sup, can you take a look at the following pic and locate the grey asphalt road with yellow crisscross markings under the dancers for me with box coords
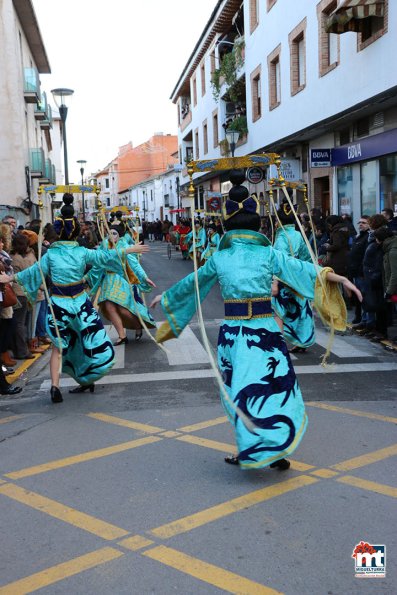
[0,243,397,595]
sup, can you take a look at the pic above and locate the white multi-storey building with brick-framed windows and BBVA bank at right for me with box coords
[171,0,397,218]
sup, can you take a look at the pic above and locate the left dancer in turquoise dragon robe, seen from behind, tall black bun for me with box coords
[0,194,148,403]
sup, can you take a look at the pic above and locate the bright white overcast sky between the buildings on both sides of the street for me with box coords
[33,0,217,183]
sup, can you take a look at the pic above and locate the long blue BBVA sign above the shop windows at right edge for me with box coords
[331,129,397,166]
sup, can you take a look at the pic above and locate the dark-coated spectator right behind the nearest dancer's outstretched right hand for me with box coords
[347,215,369,328]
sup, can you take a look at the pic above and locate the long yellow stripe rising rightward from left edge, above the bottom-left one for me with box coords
[4,436,162,479]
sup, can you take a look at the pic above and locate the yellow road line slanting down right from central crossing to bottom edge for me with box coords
[142,545,280,595]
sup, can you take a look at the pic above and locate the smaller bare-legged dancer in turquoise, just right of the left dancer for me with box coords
[85,225,156,346]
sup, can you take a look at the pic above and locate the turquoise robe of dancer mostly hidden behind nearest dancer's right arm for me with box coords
[272,225,316,348]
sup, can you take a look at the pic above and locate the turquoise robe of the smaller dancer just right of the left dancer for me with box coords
[85,234,156,328]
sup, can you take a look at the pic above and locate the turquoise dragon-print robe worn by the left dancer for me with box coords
[15,242,124,385]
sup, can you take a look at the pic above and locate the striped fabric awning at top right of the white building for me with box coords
[325,0,385,34]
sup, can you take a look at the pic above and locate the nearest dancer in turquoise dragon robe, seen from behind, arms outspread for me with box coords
[152,170,361,469]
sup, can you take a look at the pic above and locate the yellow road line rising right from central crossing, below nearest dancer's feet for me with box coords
[150,475,319,539]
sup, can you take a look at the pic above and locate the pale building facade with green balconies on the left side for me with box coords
[0,0,61,223]
